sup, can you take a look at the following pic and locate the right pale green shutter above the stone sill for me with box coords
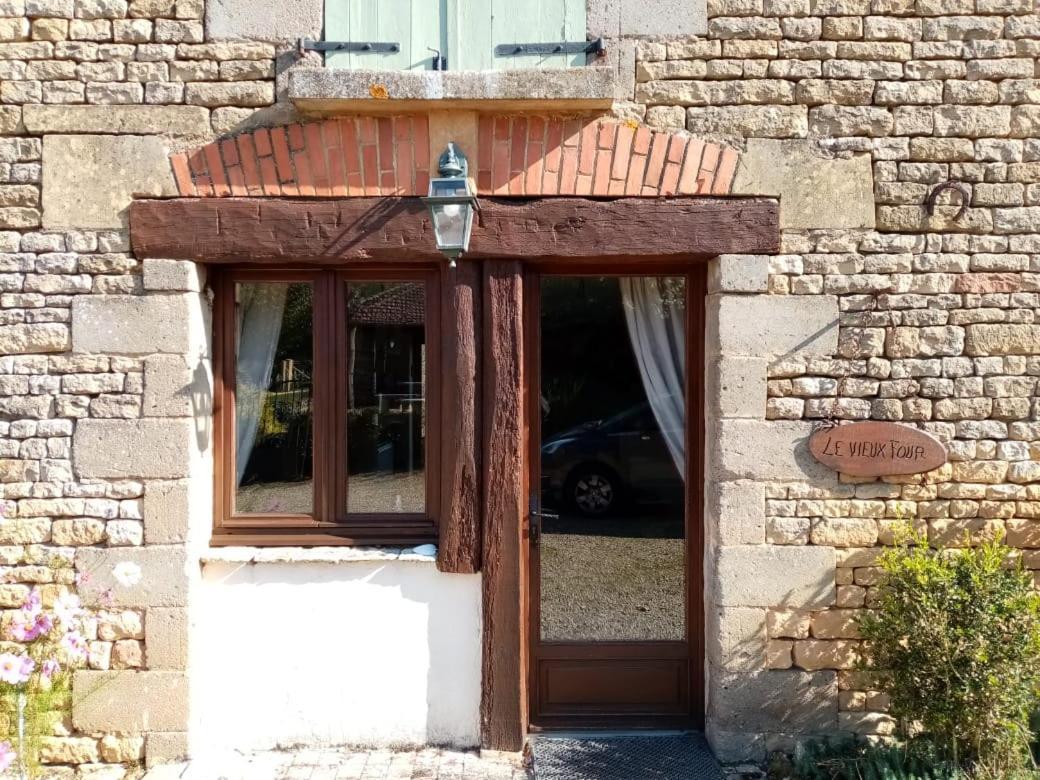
[448,0,588,71]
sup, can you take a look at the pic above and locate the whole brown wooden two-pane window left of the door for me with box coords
[214,269,439,545]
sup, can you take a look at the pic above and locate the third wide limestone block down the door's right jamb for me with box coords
[714,545,836,609]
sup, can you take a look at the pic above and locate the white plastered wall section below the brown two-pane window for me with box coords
[190,560,480,756]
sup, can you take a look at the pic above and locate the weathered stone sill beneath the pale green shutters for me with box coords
[289,66,617,113]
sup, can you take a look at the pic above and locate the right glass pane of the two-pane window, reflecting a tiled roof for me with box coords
[346,282,426,514]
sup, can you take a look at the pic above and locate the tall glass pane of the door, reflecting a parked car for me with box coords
[538,277,686,642]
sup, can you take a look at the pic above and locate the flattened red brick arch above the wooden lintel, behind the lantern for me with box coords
[171,114,738,198]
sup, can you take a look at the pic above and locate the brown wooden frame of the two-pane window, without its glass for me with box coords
[210,263,441,546]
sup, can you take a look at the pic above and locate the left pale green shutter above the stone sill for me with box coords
[326,0,451,71]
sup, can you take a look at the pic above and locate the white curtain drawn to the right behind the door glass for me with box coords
[620,277,686,479]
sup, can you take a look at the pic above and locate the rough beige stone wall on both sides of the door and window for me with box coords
[0,0,1040,778]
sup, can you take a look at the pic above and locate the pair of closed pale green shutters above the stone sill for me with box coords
[326,0,587,71]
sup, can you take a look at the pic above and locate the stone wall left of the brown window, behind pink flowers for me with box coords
[0,0,282,780]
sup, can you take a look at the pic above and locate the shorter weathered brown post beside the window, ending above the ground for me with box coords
[437,260,483,574]
